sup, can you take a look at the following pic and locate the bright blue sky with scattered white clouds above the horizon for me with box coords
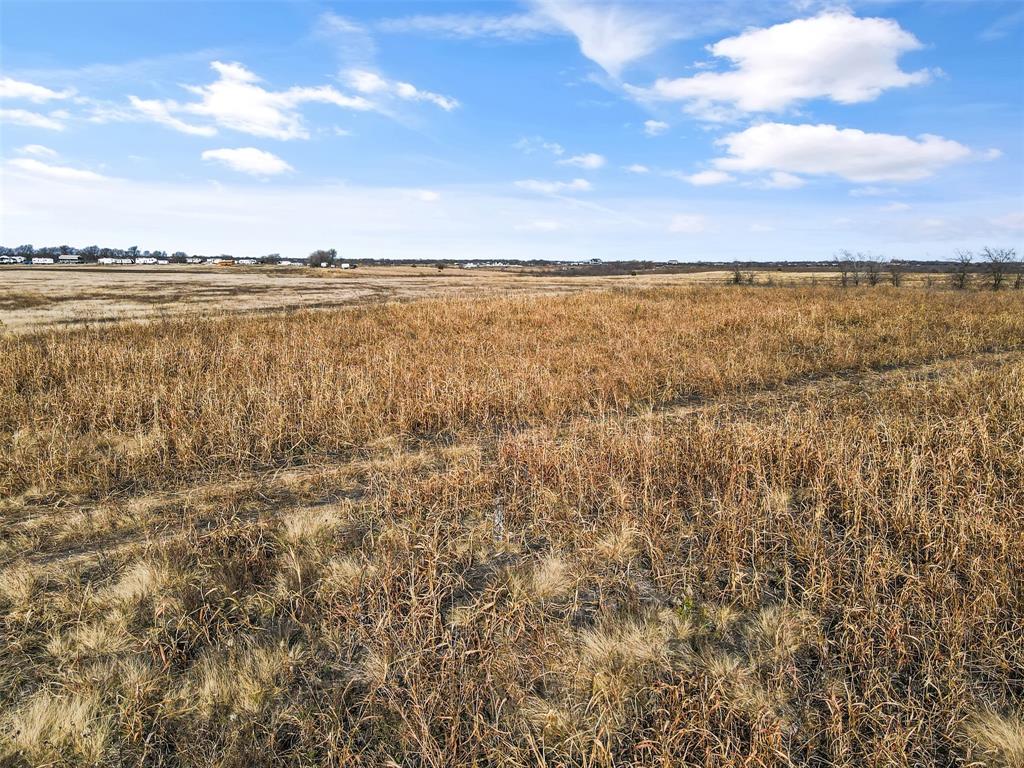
[0,0,1024,261]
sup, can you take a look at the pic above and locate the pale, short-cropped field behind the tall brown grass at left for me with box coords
[0,265,737,333]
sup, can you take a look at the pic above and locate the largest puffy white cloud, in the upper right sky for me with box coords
[631,11,931,121]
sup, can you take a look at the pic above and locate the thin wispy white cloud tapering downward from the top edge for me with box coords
[535,0,678,77]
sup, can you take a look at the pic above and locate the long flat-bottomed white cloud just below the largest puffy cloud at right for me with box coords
[714,123,971,185]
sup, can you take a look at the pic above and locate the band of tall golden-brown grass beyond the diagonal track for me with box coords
[6,289,1024,497]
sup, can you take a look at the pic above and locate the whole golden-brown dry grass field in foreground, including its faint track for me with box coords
[0,284,1024,768]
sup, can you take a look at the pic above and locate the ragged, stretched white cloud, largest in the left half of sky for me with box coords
[129,61,374,140]
